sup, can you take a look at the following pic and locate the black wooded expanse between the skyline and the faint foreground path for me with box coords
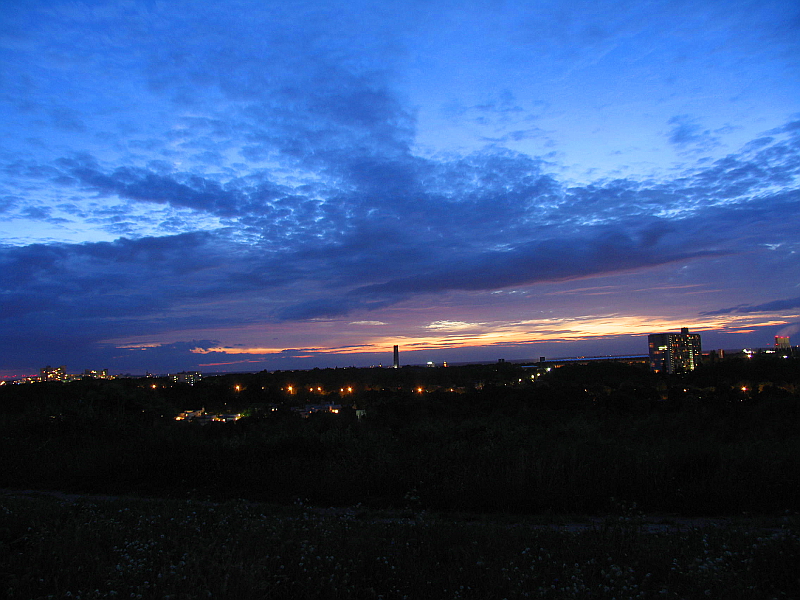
[0,358,800,514]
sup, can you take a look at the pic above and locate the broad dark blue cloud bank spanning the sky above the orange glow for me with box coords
[0,118,800,338]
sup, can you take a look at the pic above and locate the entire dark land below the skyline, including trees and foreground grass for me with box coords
[0,359,800,600]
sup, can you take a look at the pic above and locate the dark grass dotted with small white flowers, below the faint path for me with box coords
[0,495,800,600]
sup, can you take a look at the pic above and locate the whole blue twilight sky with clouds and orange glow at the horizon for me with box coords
[0,0,800,378]
